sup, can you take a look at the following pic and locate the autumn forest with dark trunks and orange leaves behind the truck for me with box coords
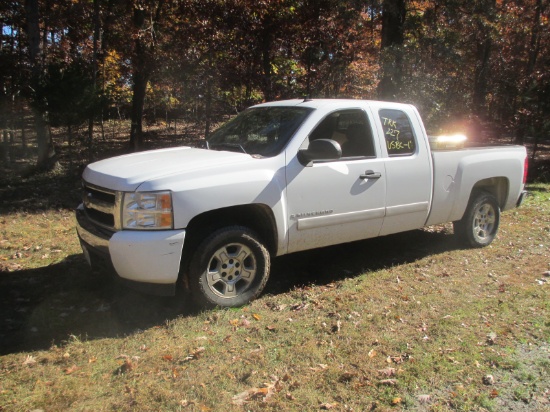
[0,0,550,172]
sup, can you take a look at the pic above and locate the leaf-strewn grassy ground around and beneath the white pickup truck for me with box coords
[0,127,550,412]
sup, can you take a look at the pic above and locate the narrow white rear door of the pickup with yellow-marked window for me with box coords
[375,108,433,235]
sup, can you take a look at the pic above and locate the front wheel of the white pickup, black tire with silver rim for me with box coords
[188,226,270,308]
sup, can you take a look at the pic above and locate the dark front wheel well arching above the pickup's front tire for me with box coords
[184,204,278,256]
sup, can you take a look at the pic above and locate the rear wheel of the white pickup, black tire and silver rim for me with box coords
[453,192,500,247]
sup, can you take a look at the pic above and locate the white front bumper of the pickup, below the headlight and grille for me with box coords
[76,205,185,295]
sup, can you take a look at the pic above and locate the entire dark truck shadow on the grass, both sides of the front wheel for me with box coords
[0,230,457,355]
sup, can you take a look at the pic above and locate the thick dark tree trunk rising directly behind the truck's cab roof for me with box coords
[377,0,407,101]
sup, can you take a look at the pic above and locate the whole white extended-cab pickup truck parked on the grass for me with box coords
[76,99,527,307]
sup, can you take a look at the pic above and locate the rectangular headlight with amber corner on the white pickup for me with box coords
[122,192,174,230]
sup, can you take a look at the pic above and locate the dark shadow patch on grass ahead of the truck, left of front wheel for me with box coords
[0,255,196,355]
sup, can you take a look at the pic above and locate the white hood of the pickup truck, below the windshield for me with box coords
[82,147,253,191]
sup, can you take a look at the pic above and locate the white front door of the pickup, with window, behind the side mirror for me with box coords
[286,109,386,252]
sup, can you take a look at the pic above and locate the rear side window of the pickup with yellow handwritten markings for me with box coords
[379,109,416,156]
